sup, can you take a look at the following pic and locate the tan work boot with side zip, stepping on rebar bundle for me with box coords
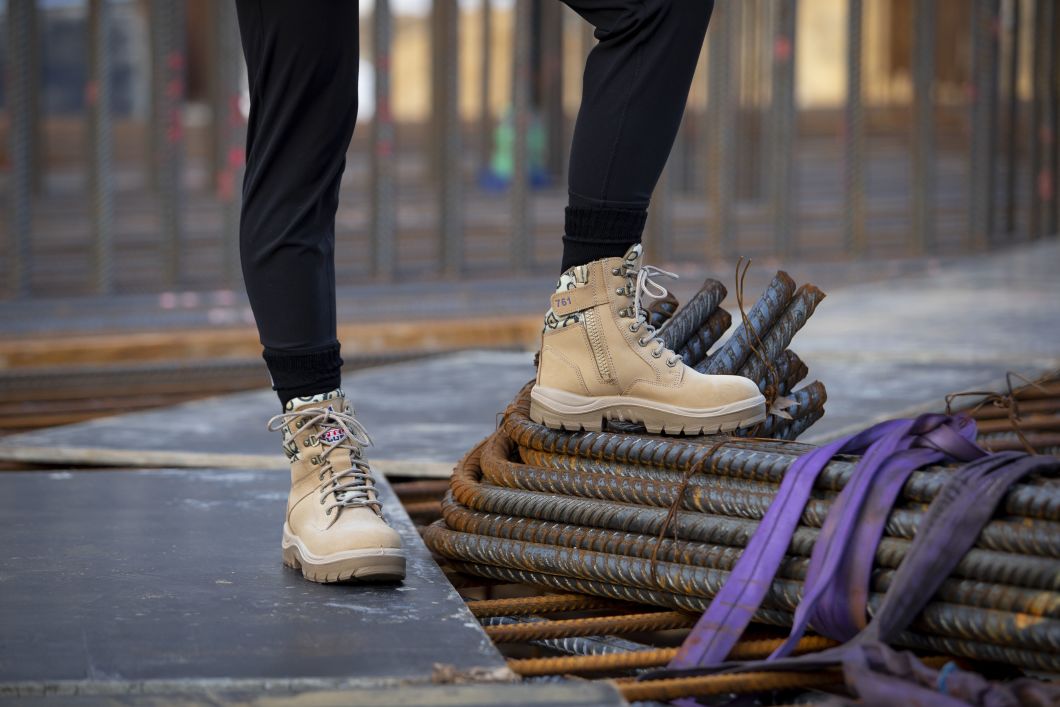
[530,244,765,435]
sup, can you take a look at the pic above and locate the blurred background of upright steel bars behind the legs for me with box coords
[0,0,1060,299]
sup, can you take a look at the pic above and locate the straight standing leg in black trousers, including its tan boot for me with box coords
[236,0,405,582]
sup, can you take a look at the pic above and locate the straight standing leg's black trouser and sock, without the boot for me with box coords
[236,0,359,403]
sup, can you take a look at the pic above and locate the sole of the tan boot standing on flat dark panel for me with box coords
[282,524,405,584]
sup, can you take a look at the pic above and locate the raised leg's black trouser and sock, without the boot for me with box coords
[561,0,713,271]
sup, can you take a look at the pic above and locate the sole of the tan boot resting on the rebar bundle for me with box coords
[530,386,765,435]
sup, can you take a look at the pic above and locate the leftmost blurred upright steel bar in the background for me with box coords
[4,0,35,297]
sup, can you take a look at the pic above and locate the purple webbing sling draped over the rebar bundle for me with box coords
[657,414,1060,705]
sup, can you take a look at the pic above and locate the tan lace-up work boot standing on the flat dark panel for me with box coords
[268,390,405,582]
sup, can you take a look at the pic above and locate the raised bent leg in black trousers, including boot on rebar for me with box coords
[530,0,765,434]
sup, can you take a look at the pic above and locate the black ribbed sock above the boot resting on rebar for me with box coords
[560,201,648,272]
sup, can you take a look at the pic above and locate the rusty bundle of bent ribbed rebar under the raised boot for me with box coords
[424,273,1060,672]
